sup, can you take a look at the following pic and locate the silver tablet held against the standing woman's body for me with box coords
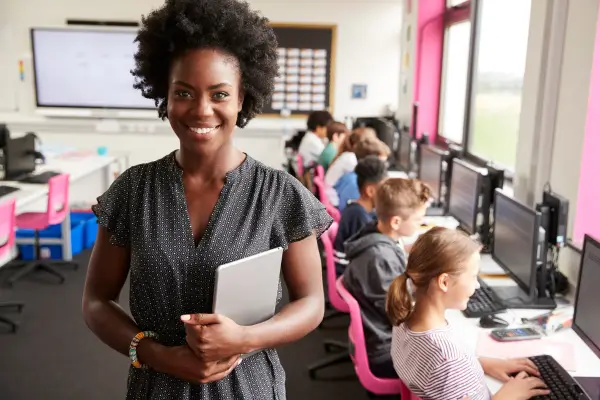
[213,247,283,326]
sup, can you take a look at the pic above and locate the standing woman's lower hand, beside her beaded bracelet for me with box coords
[140,341,242,384]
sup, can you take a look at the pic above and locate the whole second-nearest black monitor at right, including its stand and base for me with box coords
[492,189,556,309]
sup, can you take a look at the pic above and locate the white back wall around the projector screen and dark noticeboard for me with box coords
[0,0,402,123]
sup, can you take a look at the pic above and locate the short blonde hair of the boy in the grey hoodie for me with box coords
[375,178,431,221]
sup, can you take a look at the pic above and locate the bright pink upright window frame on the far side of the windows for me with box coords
[412,0,471,142]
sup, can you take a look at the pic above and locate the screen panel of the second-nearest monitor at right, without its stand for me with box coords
[492,190,541,293]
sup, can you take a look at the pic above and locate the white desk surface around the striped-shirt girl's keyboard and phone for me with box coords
[446,278,600,393]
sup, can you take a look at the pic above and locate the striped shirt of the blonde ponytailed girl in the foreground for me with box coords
[392,324,491,400]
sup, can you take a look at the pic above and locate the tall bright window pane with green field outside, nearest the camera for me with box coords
[468,0,531,170]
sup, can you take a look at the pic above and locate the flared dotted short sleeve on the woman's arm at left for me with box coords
[92,170,131,247]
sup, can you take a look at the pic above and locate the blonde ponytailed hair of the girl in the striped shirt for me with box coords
[386,227,481,326]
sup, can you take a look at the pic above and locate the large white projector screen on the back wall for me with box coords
[31,28,155,109]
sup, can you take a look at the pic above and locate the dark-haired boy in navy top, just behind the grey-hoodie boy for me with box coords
[333,156,387,276]
